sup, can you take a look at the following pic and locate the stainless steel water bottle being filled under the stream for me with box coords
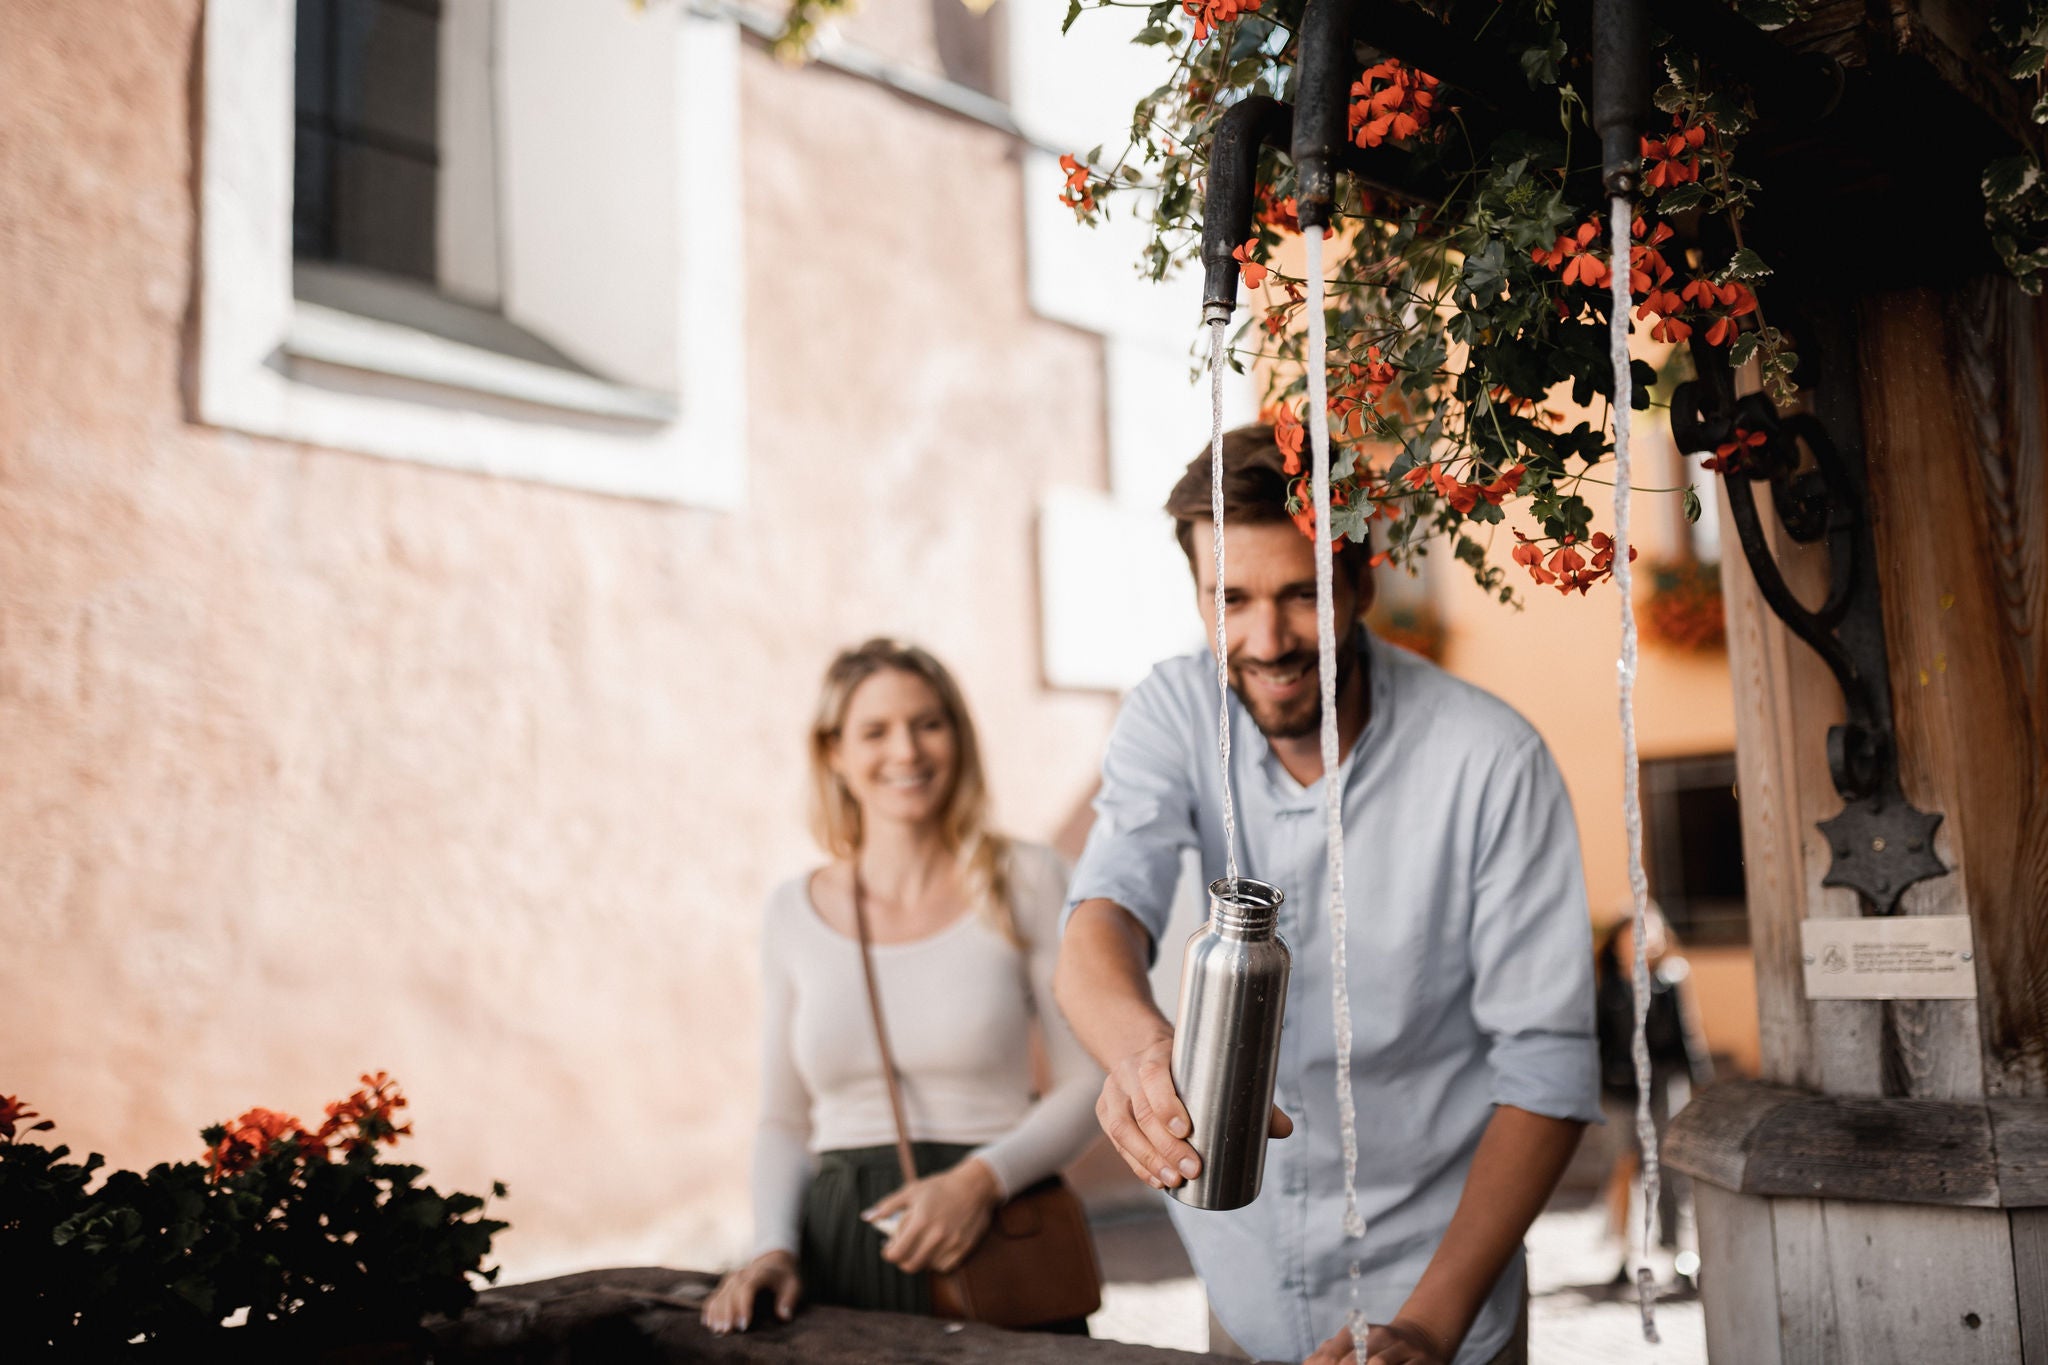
[1171,876,1294,1209]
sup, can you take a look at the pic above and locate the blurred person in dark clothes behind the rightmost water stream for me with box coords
[1593,902,1714,1283]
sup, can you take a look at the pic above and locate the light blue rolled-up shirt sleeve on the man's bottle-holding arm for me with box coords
[1061,671,1214,954]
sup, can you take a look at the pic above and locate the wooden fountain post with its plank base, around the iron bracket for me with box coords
[1667,278,2048,1365]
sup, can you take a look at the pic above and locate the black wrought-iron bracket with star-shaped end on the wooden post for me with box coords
[1671,306,1948,915]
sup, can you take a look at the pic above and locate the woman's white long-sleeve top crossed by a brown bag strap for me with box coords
[754,843,1102,1254]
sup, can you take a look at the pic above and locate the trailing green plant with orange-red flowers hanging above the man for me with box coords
[1040,0,2048,602]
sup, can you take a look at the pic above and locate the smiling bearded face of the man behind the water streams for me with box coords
[1192,518,1372,739]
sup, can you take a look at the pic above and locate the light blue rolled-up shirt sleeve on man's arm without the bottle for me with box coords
[1470,737,1599,1121]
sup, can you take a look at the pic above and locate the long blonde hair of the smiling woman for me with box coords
[811,636,1022,948]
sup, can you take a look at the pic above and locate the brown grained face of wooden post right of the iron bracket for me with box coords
[1860,280,2048,1095]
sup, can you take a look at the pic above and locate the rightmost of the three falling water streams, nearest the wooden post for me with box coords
[1608,194,1661,1342]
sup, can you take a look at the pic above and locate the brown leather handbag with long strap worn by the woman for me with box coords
[854,872,1102,1328]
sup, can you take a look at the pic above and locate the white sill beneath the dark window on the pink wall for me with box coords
[283,299,678,422]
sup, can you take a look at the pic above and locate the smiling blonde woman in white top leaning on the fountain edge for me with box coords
[702,639,1102,1332]
